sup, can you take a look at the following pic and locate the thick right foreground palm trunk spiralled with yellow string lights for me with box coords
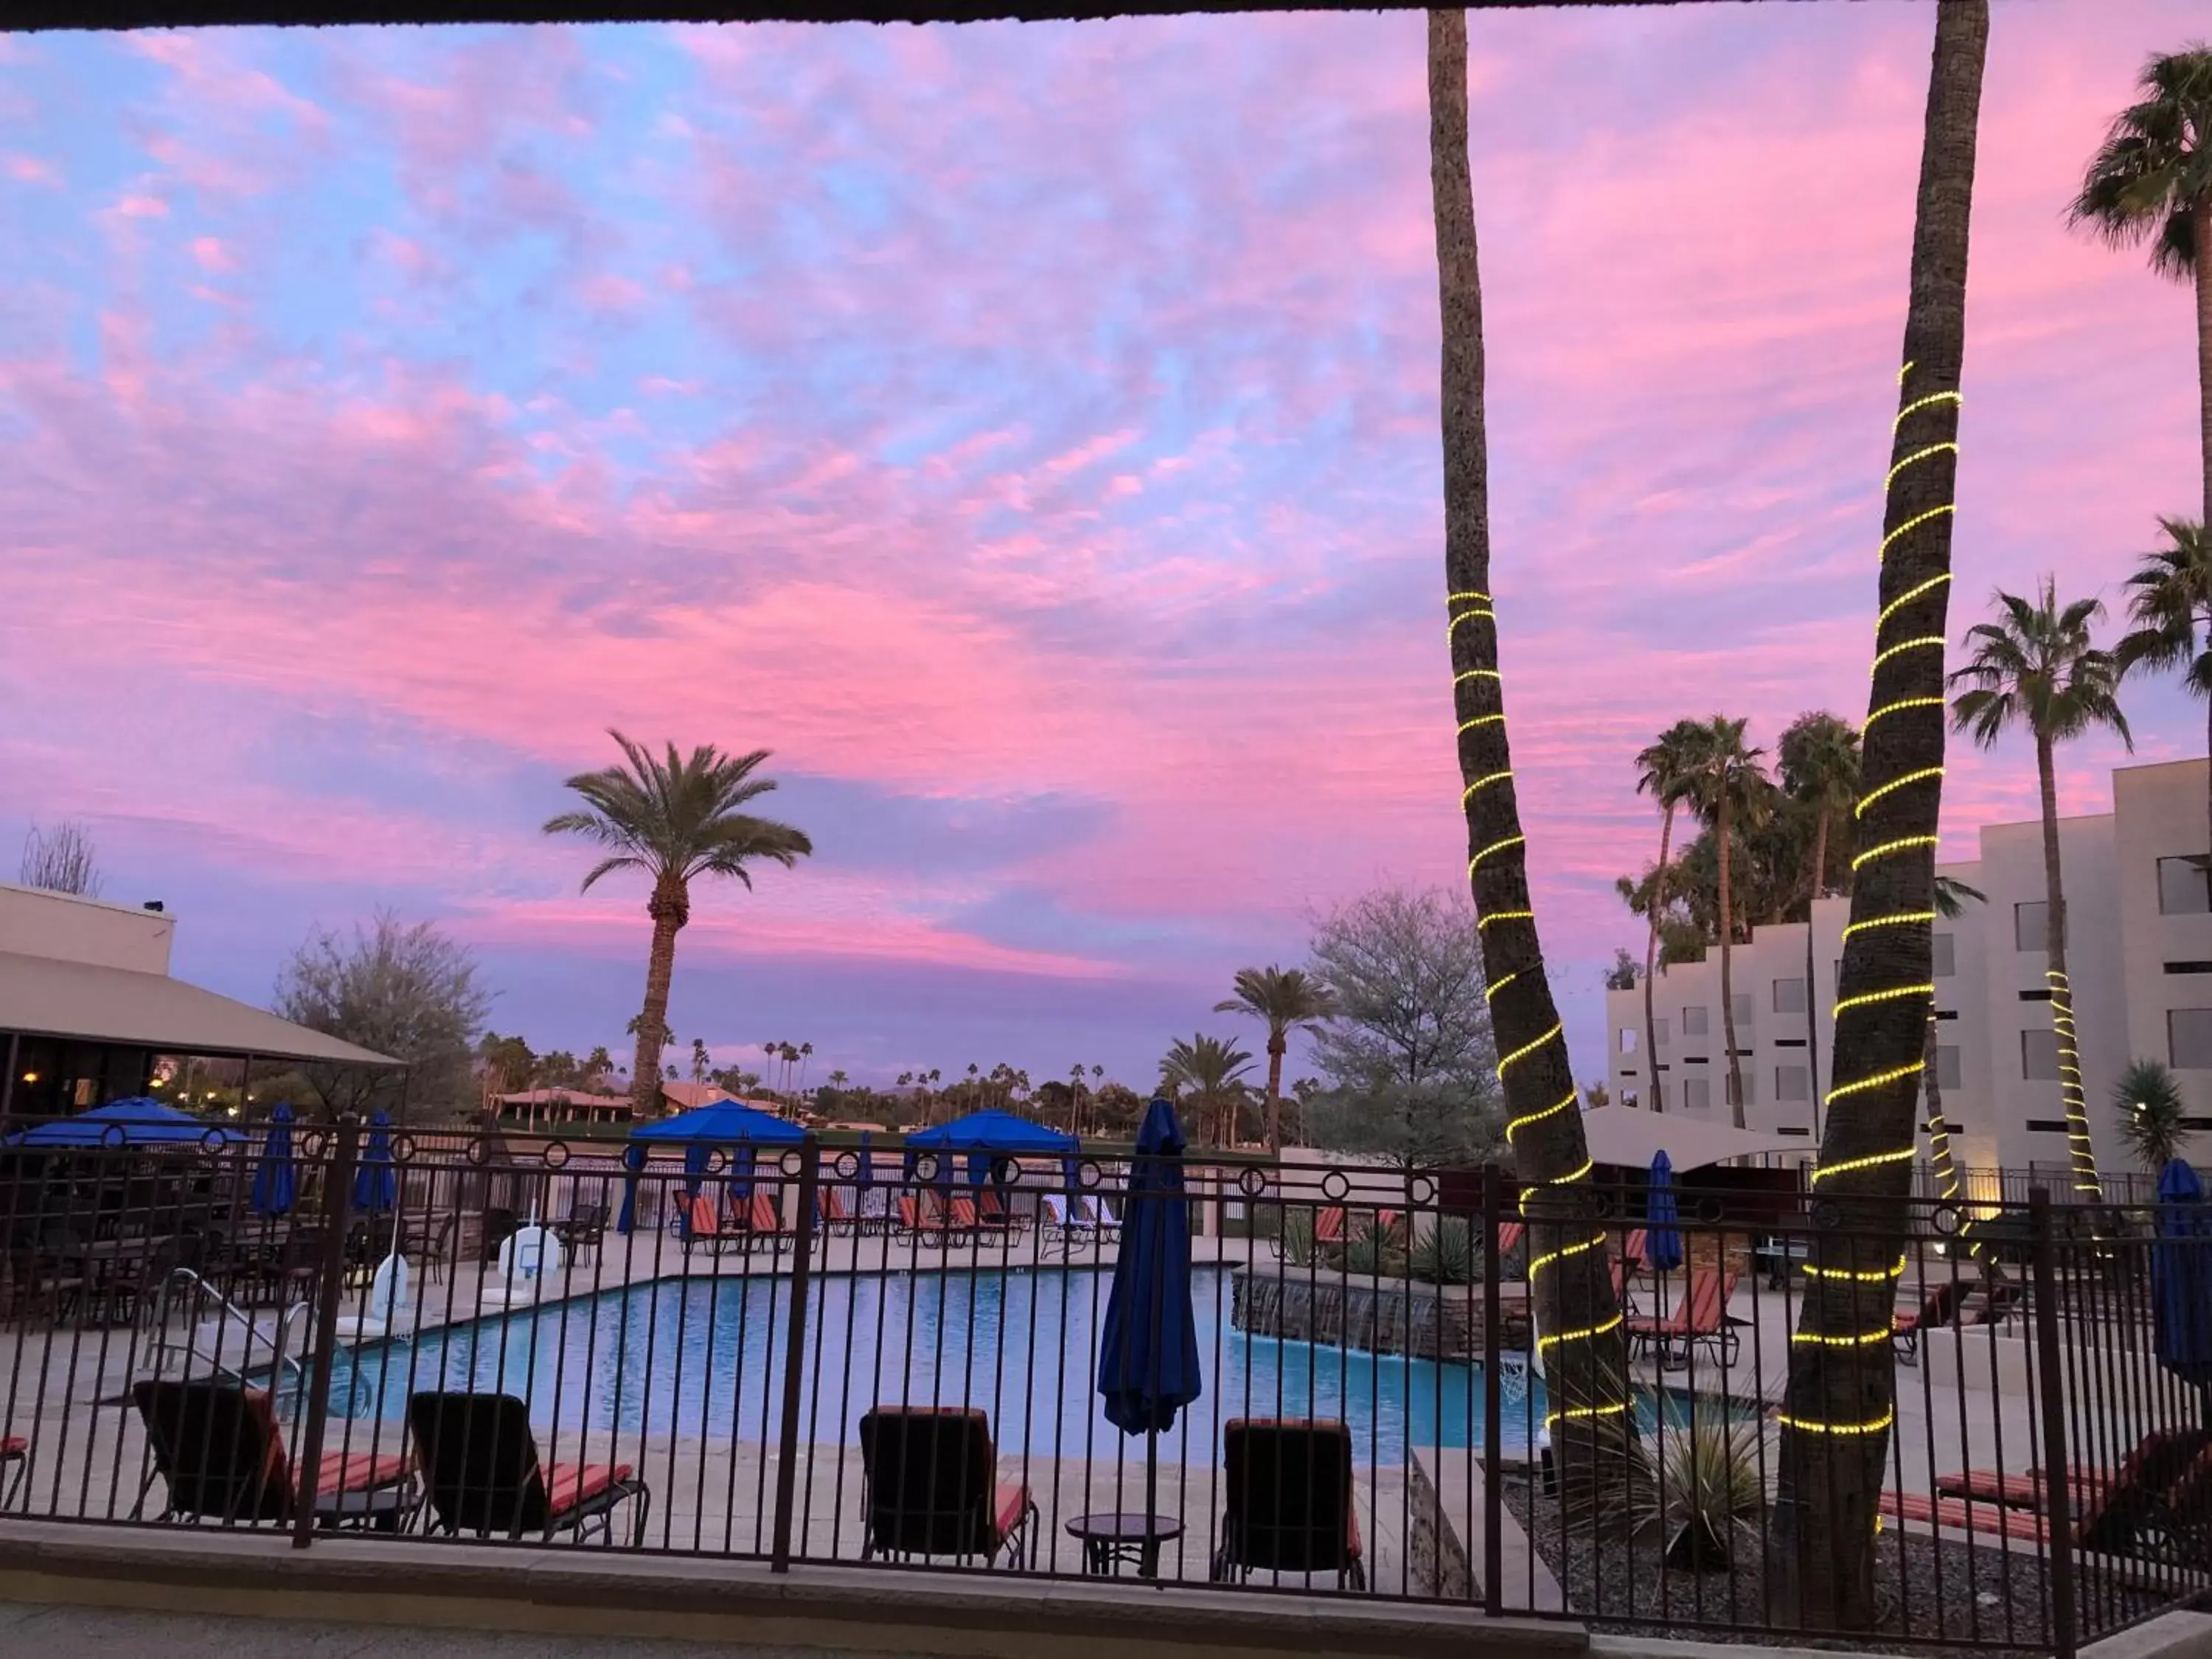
[1767,0,1989,1630]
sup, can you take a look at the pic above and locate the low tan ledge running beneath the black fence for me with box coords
[0,1520,1590,1659]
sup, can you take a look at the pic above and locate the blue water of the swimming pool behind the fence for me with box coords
[332,1267,1708,1464]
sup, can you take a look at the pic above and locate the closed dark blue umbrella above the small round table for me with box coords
[1099,1099,1203,1513]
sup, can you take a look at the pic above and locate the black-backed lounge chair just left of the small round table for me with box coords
[860,1405,1037,1566]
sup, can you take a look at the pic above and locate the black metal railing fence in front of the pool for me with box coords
[0,1124,2212,1652]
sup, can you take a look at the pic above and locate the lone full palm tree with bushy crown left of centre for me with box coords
[544,730,814,1117]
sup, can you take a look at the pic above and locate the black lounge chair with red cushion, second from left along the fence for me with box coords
[407,1394,653,1548]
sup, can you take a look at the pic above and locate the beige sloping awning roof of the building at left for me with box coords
[0,951,407,1066]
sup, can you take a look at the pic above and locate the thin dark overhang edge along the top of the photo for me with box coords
[0,0,1809,29]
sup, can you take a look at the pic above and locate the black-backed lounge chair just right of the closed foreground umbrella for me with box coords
[1212,1418,1367,1590]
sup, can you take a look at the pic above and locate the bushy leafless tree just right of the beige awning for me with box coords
[272,909,491,1113]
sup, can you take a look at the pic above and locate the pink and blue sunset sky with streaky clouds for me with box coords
[0,0,2205,1106]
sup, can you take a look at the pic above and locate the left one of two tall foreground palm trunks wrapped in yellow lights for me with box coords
[1429,11,1635,1509]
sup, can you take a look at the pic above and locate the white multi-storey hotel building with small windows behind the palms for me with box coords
[1606,761,2212,1175]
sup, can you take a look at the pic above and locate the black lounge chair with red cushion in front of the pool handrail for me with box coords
[131,1380,416,1528]
